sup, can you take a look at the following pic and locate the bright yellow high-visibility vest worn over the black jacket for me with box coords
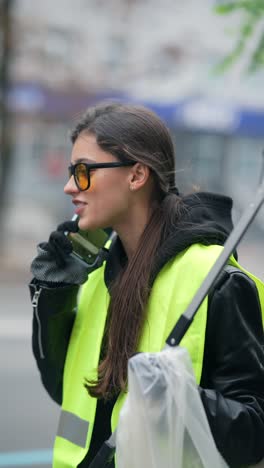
[53,244,264,468]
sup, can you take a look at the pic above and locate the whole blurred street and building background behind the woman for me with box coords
[0,0,264,467]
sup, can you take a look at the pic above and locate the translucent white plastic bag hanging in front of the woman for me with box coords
[116,347,227,468]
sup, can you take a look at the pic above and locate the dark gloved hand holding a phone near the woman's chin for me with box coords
[31,221,89,285]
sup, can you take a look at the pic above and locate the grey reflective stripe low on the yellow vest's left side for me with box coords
[57,410,89,448]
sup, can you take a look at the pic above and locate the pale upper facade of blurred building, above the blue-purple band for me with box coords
[9,0,264,101]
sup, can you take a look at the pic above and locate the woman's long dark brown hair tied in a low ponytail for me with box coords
[71,103,184,399]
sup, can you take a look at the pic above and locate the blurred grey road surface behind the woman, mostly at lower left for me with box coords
[0,239,264,467]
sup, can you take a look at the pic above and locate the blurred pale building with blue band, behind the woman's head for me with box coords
[3,0,264,266]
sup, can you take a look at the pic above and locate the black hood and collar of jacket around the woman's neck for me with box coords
[104,192,236,289]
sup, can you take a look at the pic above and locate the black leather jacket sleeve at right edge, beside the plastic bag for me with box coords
[199,269,264,467]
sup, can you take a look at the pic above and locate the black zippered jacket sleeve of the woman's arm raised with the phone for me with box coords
[29,280,79,404]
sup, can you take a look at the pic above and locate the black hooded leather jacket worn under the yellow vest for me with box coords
[30,194,264,467]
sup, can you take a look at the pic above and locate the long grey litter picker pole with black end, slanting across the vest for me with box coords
[89,158,264,468]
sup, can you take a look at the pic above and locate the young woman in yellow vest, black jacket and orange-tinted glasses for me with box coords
[30,100,264,467]
